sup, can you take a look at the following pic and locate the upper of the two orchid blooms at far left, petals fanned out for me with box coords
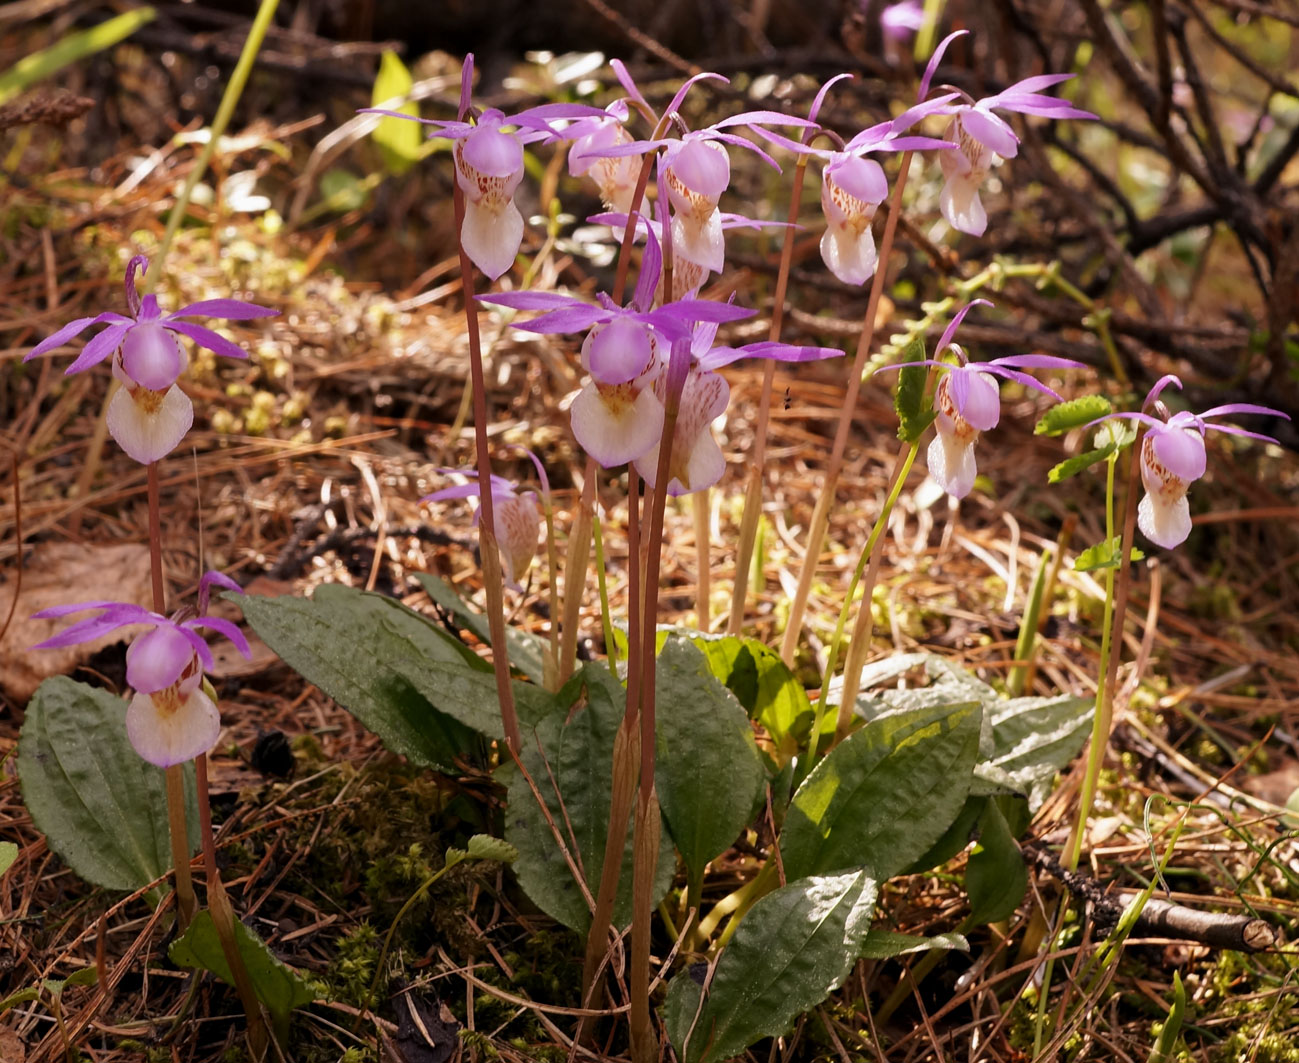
[23,255,279,465]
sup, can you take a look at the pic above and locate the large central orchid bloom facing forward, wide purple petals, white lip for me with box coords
[479,231,753,469]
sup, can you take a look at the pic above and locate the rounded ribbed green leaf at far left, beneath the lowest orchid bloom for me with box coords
[18,676,199,890]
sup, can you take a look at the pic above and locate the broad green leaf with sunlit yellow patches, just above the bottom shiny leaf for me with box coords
[781,700,983,881]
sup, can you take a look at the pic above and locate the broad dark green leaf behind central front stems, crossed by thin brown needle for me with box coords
[505,661,677,933]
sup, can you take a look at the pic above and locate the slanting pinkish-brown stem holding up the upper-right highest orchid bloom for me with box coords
[781,151,914,665]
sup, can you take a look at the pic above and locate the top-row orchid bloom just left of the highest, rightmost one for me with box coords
[757,74,955,285]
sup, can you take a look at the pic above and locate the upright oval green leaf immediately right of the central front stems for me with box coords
[655,638,766,877]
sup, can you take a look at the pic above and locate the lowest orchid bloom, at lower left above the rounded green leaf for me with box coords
[32,572,251,768]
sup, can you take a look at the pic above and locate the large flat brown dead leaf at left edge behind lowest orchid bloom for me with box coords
[0,542,153,701]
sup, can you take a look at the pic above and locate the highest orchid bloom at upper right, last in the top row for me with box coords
[920,30,1096,237]
